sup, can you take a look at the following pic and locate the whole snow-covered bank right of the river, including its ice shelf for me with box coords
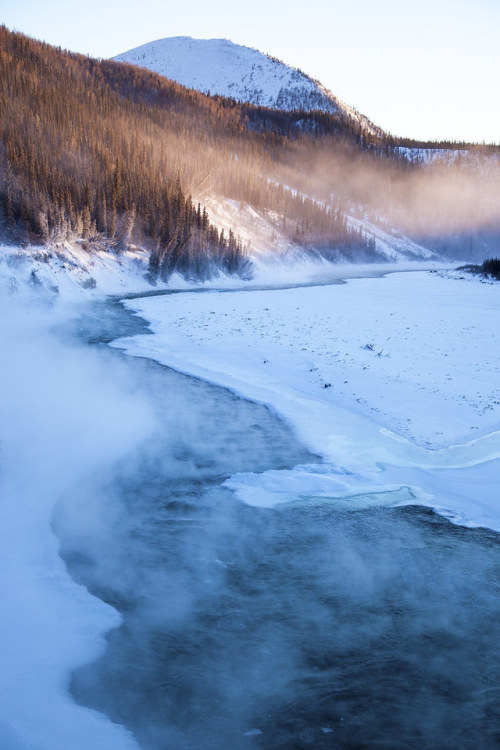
[117,272,500,529]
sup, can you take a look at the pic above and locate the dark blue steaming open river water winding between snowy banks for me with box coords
[54,301,500,750]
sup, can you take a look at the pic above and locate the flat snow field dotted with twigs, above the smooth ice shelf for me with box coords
[121,272,500,449]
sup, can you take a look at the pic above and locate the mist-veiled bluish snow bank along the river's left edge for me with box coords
[0,292,152,750]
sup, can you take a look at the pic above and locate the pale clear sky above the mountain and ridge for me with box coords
[0,0,500,143]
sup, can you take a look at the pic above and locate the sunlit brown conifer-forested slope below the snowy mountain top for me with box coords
[0,27,498,279]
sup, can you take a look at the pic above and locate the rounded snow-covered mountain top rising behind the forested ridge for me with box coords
[113,36,381,134]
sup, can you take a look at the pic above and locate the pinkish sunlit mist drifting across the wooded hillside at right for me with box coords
[194,136,500,261]
